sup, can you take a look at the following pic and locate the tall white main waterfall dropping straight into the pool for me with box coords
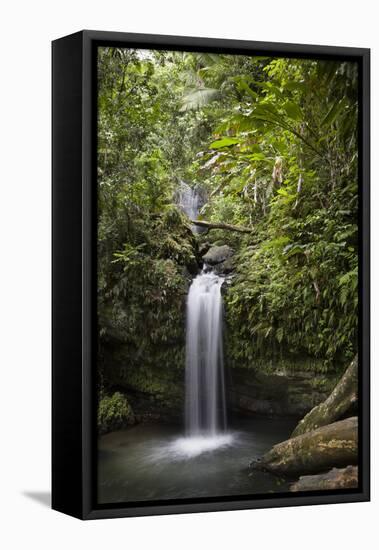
[185,271,226,436]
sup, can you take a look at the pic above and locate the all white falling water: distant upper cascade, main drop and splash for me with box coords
[172,181,233,456]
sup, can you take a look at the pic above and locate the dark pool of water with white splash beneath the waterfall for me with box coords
[98,417,295,504]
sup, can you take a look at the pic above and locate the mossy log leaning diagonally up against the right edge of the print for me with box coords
[291,357,358,437]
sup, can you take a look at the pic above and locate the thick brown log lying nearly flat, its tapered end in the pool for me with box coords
[251,416,358,477]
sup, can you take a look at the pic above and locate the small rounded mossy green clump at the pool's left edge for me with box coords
[97,392,135,434]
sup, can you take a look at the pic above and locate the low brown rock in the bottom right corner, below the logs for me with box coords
[290,466,358,492]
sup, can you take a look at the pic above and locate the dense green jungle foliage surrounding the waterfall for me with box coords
[98,48,358,432]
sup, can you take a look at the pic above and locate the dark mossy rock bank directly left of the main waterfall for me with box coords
[98,207,198,415]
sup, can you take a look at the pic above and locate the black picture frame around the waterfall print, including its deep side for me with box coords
[52,30,370,519]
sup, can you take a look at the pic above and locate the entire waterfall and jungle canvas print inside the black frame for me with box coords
[96,46,360,504]
